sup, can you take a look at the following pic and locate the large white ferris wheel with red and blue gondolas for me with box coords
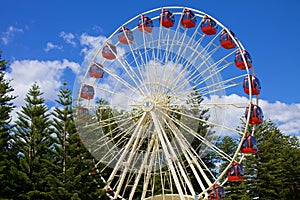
[73,6,263,200]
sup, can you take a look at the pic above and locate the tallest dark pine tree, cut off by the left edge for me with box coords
[0,52,16,199]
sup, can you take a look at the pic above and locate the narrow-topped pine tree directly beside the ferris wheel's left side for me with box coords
[50,82,106,199]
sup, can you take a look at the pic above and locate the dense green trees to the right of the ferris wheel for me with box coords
[226,120,300,200]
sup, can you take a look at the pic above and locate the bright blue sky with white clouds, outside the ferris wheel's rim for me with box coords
[0,0,300,136]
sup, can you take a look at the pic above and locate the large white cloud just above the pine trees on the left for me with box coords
[7,59,79,106]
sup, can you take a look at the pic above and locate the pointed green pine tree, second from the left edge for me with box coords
[14,83,52,199]
